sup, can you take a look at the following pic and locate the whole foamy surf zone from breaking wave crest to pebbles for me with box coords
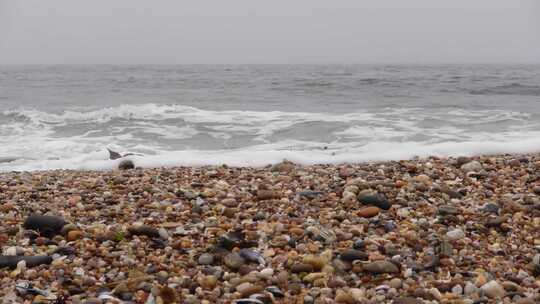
[0,104,540,171]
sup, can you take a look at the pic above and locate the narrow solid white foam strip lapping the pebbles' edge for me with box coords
[0,138,540,171]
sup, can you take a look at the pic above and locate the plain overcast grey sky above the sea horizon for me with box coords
[0,0,540,64]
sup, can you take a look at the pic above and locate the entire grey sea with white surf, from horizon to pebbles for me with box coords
[0,64,540,172]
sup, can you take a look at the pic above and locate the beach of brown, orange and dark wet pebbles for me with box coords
[0,154,540,304]
